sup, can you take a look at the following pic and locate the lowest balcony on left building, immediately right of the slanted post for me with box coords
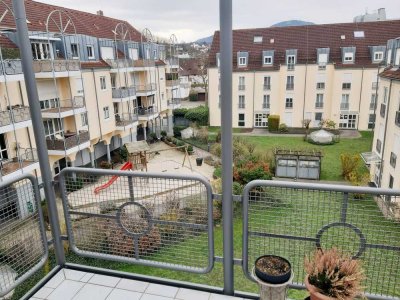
[46,130,90,155]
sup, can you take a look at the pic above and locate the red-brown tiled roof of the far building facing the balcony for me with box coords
[209,20,400,70]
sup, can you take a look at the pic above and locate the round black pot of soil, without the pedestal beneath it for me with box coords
[255,255,292,284]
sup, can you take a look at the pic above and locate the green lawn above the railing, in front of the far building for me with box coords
[244,131,373,181]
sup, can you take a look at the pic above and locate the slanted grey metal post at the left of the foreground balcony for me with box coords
[12,0,65,265]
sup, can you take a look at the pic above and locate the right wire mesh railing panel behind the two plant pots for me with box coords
[243,181,400,299]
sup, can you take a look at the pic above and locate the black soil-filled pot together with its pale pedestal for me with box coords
[253,255,293,300]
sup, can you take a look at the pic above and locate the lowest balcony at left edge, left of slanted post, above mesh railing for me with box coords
[0,148,39,180]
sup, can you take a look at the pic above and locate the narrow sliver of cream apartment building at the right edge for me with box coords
[363,38,400,189]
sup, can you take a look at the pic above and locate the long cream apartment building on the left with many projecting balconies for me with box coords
[0,0,180,180]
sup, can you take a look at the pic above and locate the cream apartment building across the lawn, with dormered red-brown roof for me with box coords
[208,20,400,130]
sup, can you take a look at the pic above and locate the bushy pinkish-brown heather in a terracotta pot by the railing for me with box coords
[304,248,365,300]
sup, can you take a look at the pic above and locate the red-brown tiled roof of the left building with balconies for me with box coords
[1,0,141,42]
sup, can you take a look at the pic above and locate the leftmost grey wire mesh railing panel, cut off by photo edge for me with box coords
[0,176,48,297]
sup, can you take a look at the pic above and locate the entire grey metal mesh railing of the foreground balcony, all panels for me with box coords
[0,168,400,300]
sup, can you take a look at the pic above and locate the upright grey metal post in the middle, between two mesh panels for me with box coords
[219,0,234,295]
